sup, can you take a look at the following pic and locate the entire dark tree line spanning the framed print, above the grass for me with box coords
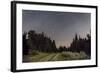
[23,30,91,55]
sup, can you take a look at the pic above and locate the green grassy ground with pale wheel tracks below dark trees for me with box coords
[23,52,88,62]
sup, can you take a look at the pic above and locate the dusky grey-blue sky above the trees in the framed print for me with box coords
[22,10,91,47]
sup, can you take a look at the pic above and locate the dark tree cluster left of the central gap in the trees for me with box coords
[23,30,57,54]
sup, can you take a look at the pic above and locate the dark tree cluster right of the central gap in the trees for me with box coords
[70,34,91,56]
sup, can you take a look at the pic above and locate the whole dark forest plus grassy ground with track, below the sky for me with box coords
[22,30,91,62]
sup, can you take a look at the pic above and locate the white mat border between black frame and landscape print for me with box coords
[16,4,96,70]
